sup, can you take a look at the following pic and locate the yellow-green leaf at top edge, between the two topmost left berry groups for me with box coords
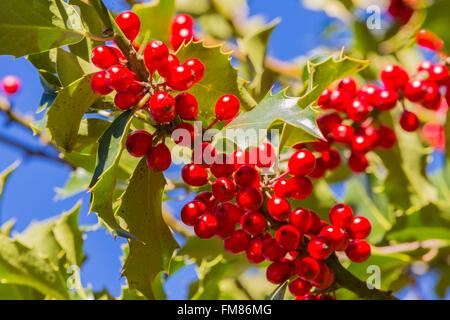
[133,0,176,42]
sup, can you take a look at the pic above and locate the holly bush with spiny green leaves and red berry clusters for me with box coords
[0,0,450,300]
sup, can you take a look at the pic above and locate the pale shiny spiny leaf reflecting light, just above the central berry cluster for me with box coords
[217,91,322,149]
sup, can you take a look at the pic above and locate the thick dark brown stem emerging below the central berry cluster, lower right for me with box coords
[326,255,398,300]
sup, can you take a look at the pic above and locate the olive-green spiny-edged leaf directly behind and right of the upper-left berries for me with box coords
[177,41,247,118]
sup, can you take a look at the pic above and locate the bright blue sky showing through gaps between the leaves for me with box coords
[0,0,442,298]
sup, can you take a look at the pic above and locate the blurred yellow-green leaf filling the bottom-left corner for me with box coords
[0,234,69,299]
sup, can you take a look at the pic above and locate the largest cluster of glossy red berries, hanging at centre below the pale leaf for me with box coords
[181,143,371,298]
